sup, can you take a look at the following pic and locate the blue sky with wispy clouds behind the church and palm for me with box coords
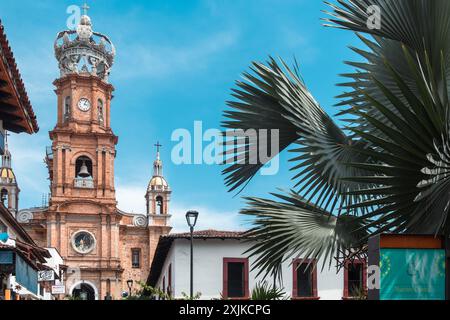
[0,0,358,230]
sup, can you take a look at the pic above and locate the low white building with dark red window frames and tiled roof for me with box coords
[148,230,367,300]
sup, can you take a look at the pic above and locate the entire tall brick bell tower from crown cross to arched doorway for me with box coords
[46,6,123,299]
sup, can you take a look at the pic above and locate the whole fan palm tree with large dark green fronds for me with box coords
[223,0,450,275]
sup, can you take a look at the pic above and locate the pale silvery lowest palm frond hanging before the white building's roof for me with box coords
[241,192,367,276]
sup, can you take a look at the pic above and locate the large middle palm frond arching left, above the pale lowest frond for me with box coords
[223,59,368,211]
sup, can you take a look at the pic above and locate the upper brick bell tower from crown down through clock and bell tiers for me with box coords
[50,10,118,205]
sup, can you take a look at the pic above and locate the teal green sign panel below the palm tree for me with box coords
[380,249,445,300]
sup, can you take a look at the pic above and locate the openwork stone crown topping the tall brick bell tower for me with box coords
[55,6,116,82]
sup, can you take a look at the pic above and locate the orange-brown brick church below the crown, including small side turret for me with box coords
[19,64,171,299]
